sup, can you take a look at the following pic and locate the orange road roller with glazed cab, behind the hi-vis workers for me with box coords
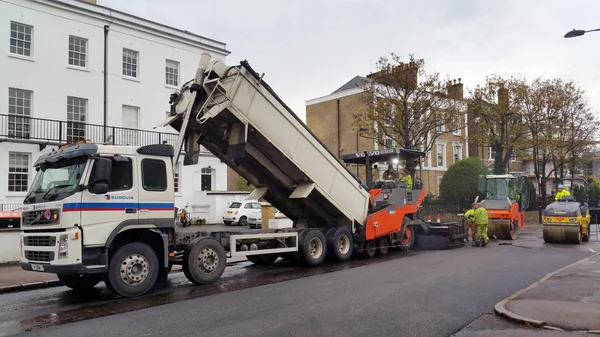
[479,174,530,240]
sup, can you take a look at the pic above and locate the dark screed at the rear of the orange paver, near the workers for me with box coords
[417,220,468,250]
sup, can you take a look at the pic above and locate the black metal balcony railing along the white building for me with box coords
[0,114,213,153]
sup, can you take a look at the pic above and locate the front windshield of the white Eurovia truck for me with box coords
[23,157,87,204]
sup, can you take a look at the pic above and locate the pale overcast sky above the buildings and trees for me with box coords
[97,0,600,120]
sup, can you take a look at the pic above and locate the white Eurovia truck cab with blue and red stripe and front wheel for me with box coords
[21,142,174,292]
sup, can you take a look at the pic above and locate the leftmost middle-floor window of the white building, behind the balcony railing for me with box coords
[8,88,33,138]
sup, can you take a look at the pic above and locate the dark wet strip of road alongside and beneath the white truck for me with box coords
[15,251,415,330]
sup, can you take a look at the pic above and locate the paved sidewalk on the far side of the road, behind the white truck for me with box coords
[0,256,246,294]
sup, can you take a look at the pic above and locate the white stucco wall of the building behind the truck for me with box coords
[0,0,229,210]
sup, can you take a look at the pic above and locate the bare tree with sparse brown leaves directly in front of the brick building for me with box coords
[354,53,465,174]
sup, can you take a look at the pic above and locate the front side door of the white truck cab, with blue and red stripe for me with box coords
[79,156,139,245]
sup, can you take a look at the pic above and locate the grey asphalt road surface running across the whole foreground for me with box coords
[0,228,600,337]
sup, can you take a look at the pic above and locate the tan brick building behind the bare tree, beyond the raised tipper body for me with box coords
[306,68,469,195]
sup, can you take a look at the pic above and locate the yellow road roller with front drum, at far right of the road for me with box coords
[542,178,591,244]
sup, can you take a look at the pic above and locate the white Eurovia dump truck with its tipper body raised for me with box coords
[21,54,454,297]
